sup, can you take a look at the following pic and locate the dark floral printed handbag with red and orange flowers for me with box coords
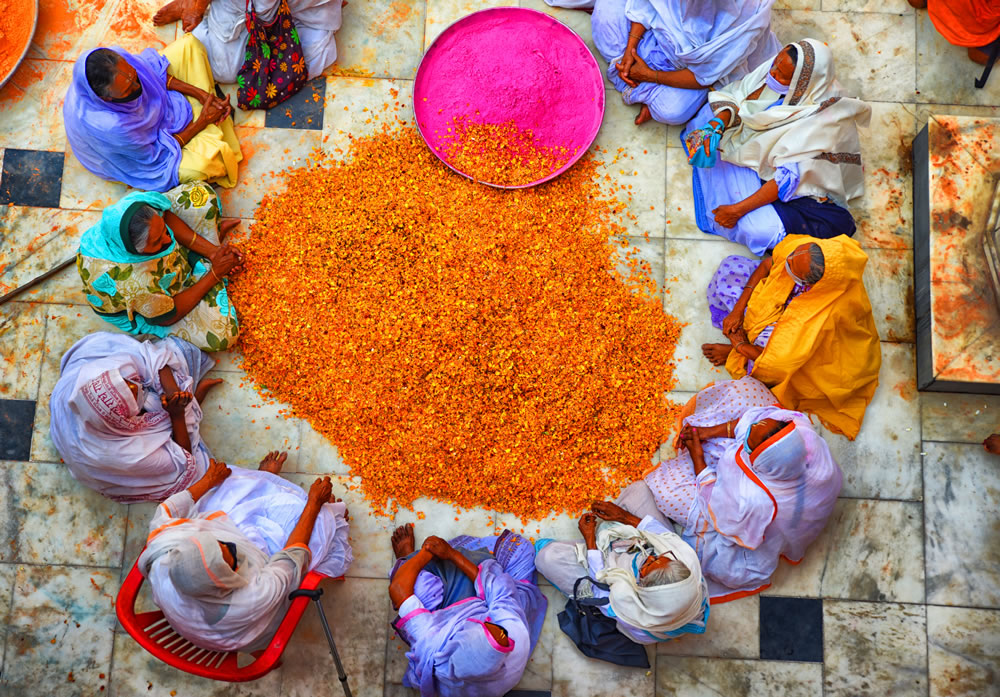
[236,0,308,109]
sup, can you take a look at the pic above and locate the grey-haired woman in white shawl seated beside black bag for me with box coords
[535,482,709,644]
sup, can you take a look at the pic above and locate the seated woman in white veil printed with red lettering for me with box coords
[49,332,222,503]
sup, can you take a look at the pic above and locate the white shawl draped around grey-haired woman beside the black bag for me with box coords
[577,523,708,641]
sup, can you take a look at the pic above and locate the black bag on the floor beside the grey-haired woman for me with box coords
[559,576,649,668]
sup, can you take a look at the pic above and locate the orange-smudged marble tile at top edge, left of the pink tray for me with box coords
[326,0,425,79]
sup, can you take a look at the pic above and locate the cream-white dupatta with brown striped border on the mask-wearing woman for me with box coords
[708,39,871,208]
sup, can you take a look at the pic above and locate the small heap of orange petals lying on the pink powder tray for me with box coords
[437,116,575,186]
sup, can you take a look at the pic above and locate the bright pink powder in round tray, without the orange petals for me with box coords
[413,7,604,188]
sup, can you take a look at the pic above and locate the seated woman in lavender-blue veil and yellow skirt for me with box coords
[63,34,243,191]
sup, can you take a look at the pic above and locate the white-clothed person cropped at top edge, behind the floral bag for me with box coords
[153,0,343,82]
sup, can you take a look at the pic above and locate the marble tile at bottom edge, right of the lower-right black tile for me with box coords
[823,600,927,697]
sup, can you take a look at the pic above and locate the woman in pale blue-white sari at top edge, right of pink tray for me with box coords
[546,0,781,125]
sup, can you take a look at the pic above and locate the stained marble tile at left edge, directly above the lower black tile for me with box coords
[0,302,45,399]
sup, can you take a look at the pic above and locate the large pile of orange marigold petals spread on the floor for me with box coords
[231,125,680,518]
